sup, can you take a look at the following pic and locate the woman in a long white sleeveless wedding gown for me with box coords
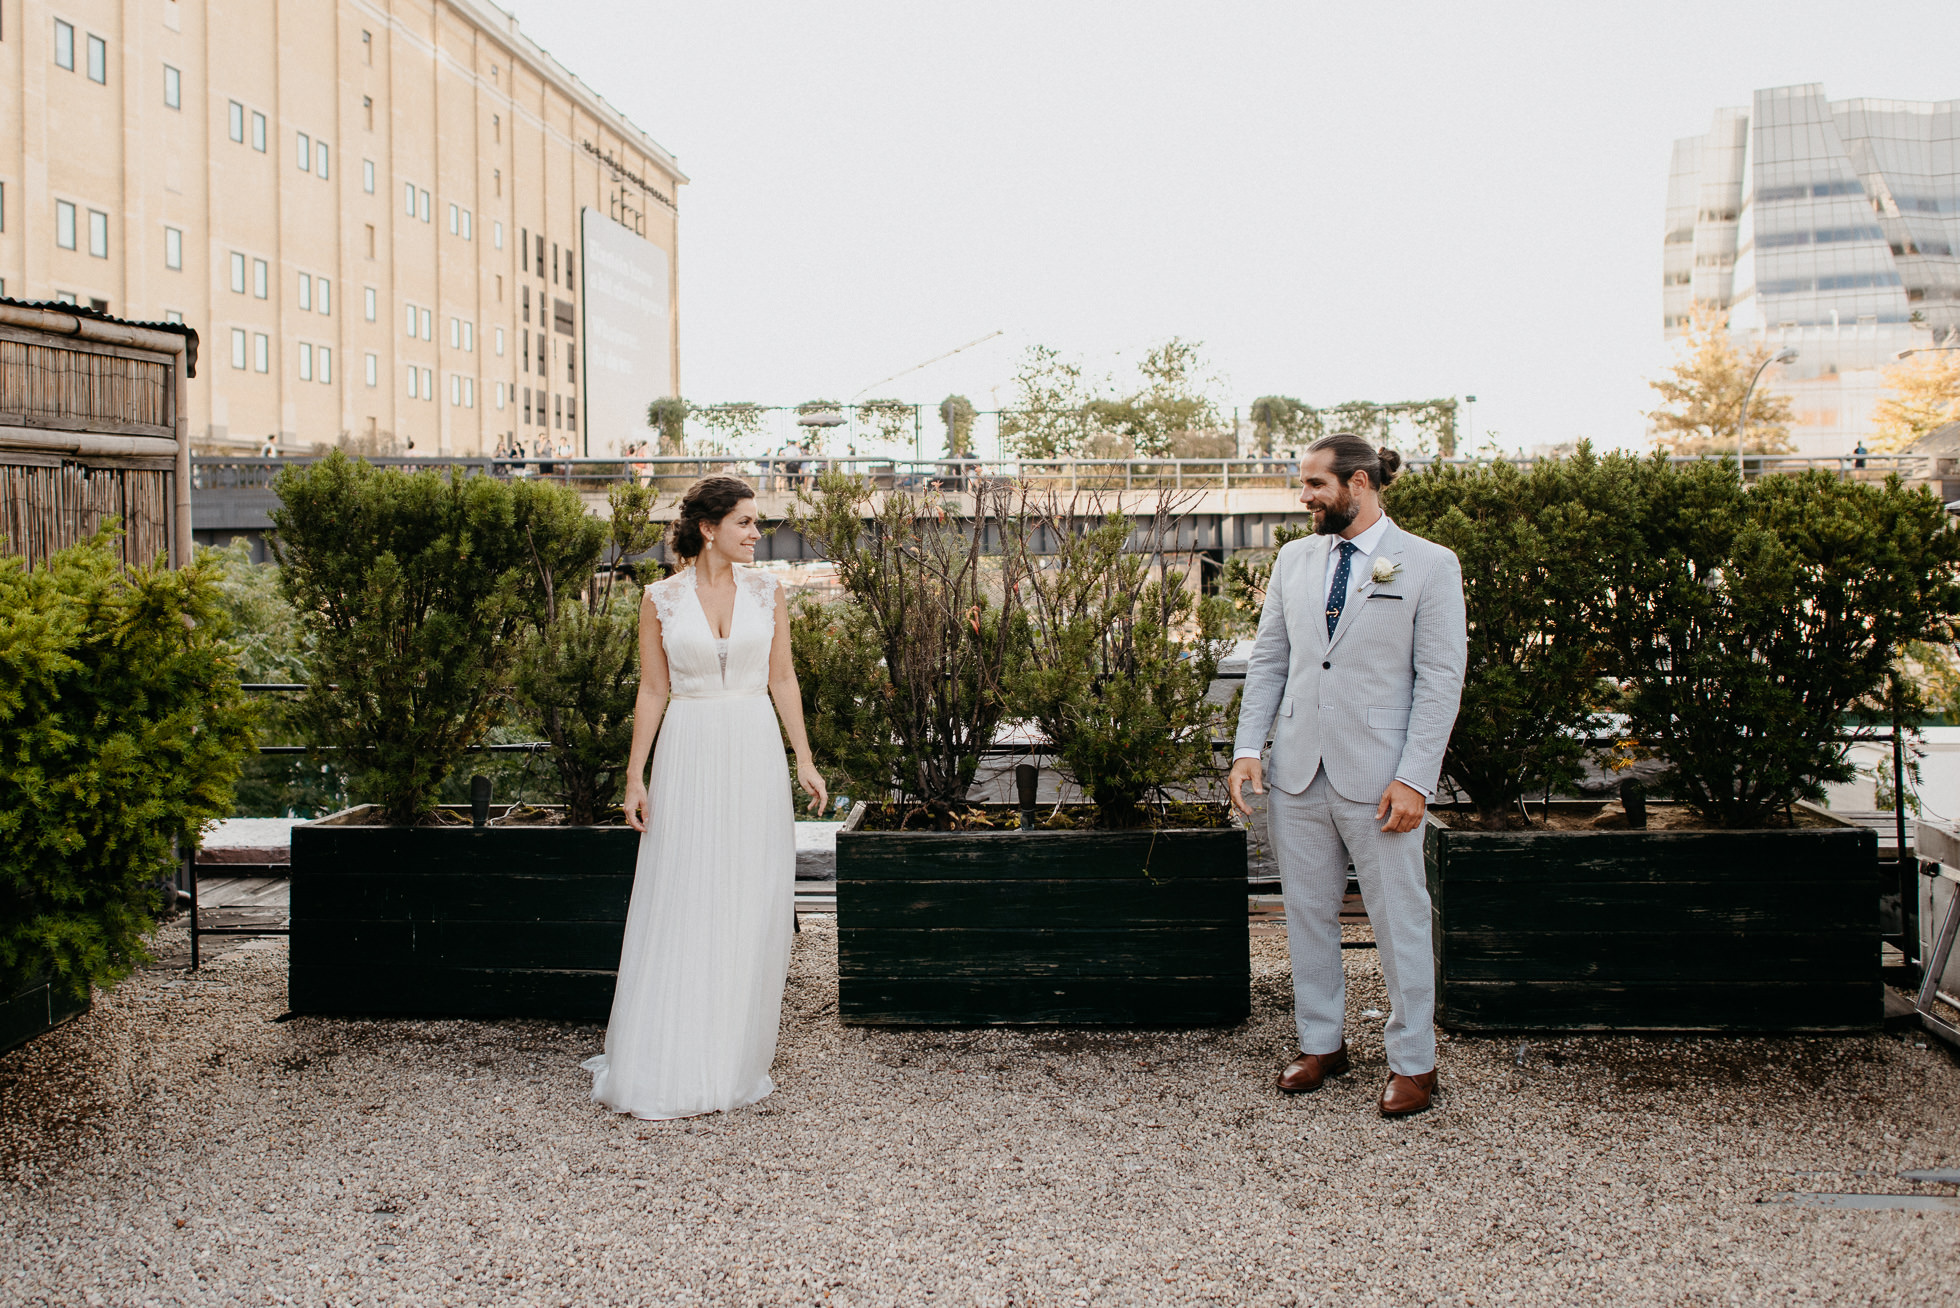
[584,477,827,1120]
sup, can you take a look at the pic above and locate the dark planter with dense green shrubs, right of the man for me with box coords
[1392,455,1960,1030]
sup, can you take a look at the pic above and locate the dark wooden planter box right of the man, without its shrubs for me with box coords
[1425,804,1884,1031]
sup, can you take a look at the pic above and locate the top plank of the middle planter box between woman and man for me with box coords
[837,830,1245,886]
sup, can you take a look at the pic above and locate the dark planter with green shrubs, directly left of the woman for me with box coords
[274,453,635,1020]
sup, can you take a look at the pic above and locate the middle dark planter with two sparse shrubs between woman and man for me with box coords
[800,478,1249,1026]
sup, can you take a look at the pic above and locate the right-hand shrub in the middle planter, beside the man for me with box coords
[1002,494,1231,828]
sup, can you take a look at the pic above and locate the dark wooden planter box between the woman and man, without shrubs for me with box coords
[837,830,1250,1026]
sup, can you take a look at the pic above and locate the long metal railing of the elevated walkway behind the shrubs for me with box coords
[190,453,1935,494]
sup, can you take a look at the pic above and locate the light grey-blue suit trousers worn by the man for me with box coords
[1266,769,1437,1077]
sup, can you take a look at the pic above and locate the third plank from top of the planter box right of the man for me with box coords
[1439,930,1880,982]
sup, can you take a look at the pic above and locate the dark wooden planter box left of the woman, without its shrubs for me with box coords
[288,808,639,1022]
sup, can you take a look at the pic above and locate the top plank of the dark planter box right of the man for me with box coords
[1431,828,1878,884]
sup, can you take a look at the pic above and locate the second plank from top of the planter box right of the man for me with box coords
[1441,869,1878,929]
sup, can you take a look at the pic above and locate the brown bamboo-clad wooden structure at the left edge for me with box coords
[0,300,198,569]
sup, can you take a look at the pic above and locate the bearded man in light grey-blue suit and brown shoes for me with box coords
[1229,431,1466,1118]
